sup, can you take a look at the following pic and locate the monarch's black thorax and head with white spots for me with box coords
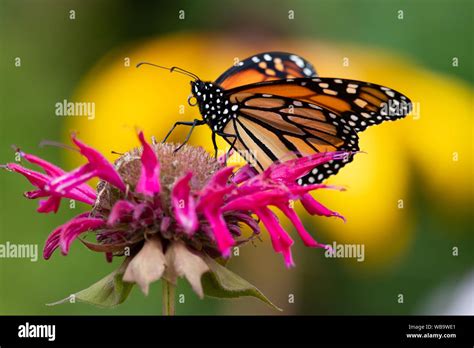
[191,81,238,132]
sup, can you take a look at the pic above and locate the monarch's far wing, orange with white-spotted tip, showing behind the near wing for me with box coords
[215,52,317,89]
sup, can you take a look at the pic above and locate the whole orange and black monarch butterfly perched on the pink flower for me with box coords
[137,52,411,185]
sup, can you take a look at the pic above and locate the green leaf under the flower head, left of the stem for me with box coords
[47,258,134,307]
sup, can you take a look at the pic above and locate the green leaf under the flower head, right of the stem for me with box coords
[201,256,282,311]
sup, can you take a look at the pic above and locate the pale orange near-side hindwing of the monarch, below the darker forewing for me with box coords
[225,94,358,174]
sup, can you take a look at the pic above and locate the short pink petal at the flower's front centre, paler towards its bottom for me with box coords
[171,173,199,235]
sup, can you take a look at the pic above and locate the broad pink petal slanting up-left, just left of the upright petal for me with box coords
[72,135,125,192]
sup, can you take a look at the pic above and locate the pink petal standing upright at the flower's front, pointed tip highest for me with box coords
[135,132,160,196]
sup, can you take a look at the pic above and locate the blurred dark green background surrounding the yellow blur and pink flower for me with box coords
[0,0,474,314]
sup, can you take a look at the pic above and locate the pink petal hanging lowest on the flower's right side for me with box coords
[255,208,295,268]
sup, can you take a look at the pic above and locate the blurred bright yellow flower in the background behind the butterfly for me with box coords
[65,34,473,269]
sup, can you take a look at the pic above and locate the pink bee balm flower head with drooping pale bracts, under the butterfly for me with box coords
[5,132,347,296]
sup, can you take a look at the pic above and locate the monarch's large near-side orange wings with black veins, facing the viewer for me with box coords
[224,78,411,184]
